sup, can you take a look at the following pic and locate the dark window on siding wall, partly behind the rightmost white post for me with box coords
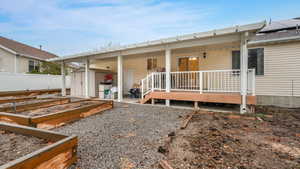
[232,48,264,75]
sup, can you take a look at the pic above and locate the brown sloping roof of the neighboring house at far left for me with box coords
[0,36,58,60]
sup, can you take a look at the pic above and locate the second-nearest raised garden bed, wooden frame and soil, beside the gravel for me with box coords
[0,100,113,129]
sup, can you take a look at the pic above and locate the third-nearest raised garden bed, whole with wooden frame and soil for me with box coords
[0,98,70,112]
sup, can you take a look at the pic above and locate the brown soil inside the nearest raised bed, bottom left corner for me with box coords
[0,130,47,166]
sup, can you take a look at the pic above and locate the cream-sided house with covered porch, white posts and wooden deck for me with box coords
[51,18,300,113]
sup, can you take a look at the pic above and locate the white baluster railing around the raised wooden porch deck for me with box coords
[141,69,255,98]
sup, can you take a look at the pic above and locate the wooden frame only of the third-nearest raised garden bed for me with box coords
[0,98,71,113]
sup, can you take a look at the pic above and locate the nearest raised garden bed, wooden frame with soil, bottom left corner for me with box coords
[0,122,78,169]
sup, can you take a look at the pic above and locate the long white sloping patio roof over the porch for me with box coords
[48,21,266,62]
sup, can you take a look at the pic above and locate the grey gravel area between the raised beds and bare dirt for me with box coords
[55,103,192,169]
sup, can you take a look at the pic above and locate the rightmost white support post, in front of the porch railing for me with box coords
[240,32,248,114]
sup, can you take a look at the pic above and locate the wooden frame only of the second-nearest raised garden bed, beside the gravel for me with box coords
[0,100,113,129]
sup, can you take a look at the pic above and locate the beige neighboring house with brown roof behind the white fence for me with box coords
[0,36,57,73]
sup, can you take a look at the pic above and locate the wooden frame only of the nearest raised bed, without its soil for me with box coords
[0,122,78,169]
